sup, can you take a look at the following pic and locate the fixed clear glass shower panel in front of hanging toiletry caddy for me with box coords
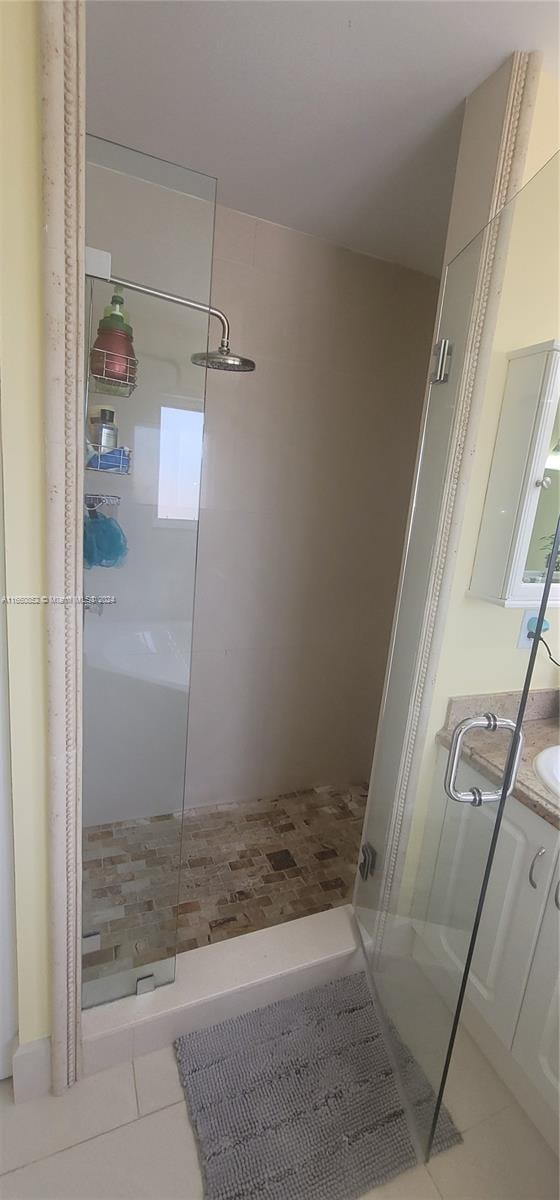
[82,139,215,1007]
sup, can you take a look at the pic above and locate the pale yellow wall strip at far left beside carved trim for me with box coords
[0,2,49,1043]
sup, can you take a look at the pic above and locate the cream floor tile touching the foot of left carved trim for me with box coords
[0,1063,138,1171]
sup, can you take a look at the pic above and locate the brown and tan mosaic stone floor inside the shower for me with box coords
[83,784,367,982]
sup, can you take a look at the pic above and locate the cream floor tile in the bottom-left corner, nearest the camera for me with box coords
[0,1104,203,1200]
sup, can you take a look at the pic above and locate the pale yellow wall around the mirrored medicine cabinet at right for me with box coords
[439,163,560,695]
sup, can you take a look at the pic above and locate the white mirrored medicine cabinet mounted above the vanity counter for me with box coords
[470,341,560,608]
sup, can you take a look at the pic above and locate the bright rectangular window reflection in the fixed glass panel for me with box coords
[157,408,204,521]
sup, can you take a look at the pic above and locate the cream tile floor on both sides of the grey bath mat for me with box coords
[0,1032,559,1200]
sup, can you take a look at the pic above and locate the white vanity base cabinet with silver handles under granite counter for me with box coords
[414,746,560,1145]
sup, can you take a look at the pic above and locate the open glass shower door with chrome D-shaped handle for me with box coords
[355,160,560,1157]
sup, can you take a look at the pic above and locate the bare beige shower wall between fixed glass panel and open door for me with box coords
[187,209,438,804]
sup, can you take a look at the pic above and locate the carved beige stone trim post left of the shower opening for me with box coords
[41,0,85,1093]
